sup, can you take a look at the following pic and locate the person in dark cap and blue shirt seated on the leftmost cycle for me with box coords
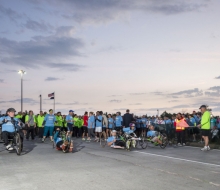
[0,108,24,150]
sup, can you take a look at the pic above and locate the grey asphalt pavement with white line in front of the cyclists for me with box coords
[0,139,220,190]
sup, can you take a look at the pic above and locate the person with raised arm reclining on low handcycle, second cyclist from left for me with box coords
[54,128,73,152]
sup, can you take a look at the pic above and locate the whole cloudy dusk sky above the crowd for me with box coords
[0,0,220,115]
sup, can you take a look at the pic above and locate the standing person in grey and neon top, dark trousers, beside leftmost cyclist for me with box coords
[25,110,36,140]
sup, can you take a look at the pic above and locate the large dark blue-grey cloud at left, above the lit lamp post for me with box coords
[0,28,84,71]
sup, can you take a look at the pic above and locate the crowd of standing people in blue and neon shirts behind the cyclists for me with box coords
[0,105,220,150]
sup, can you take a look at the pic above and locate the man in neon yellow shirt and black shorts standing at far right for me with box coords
[198,105,211,151]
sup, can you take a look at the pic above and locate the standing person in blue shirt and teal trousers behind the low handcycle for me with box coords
[42,109,56,142]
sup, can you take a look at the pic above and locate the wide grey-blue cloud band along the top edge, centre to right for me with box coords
[26,0,207,23]
